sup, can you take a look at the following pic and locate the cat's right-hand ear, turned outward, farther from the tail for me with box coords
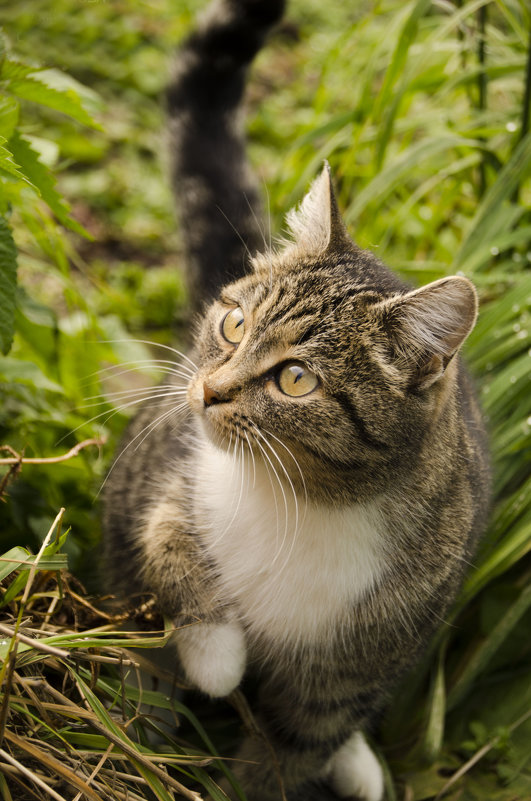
[376,276,478,389]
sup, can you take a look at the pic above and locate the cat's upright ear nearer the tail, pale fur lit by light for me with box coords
[286,162,352,256]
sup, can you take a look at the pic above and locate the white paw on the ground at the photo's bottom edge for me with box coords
[326,732,384,801]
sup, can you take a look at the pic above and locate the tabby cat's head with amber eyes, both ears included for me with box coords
[188,167,477,502]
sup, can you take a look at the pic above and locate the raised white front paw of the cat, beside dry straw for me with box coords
[175,620,246,697]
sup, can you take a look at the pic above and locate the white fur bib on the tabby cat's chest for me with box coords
[193,445,385,643]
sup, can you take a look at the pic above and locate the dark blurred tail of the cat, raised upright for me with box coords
[166,0,285,309]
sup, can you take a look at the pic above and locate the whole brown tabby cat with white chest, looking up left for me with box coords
[104,0,490,801]
